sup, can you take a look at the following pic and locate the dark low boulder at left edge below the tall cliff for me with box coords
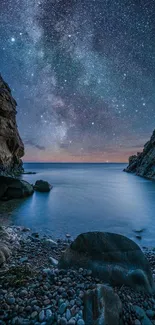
[0,176,34,200]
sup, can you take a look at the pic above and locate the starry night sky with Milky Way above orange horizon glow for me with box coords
[0,0,155,162]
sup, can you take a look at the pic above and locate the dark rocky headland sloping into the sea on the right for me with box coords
[125,130,155,180]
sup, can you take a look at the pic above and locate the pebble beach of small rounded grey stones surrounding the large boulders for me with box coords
[0,227,155,325]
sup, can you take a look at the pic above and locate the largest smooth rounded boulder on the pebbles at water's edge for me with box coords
[59,232,154,293]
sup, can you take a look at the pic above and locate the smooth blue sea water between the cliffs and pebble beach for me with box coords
[1,163,155,246]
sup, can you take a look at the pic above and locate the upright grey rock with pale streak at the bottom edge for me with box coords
[83,285,122,325]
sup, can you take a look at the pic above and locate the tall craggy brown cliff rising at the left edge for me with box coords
[0,75,24,174]
